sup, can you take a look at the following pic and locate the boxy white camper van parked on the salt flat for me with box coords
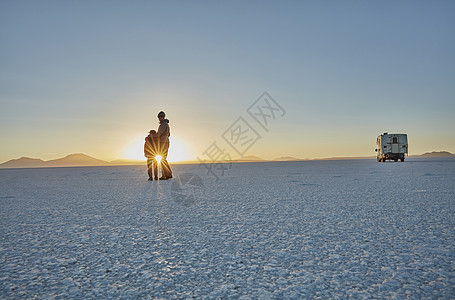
[376,132,408,162]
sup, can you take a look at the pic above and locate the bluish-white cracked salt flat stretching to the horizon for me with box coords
[0,159,455,299]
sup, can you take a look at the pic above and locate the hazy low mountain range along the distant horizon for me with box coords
[0,151,455,168]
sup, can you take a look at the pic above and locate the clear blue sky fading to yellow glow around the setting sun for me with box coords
[0,0,455,163]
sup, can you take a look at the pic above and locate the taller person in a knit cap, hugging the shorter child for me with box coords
[152,111,172,180]
